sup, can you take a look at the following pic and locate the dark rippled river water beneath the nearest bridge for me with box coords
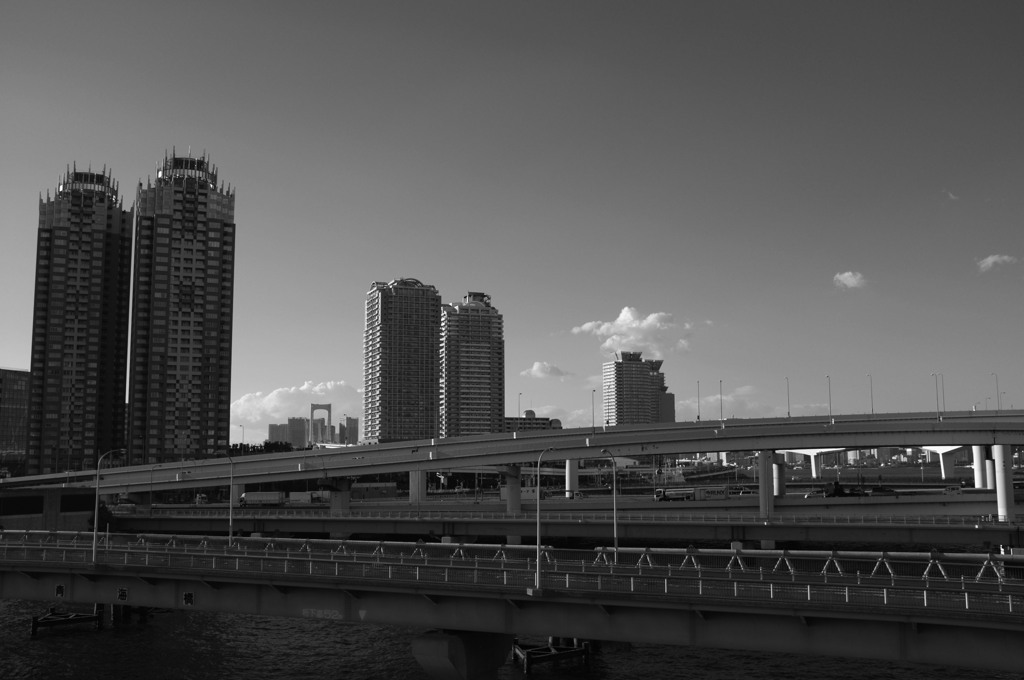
[0,601,1024,680]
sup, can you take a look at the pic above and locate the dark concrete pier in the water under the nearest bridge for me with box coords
[412,631,513,680]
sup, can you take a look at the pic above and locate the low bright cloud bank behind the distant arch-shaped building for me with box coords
[231,381,362,443]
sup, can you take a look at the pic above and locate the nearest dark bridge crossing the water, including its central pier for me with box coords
[0,532,1024,678]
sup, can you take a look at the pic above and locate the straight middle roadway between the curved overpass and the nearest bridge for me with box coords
[113,499,1024,550]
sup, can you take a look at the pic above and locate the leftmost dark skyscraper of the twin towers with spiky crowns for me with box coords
[25,168,132,474]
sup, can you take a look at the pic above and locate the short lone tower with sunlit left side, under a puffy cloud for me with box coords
[602,352,676,425]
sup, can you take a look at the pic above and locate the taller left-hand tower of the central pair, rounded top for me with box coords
[362,279,441,443]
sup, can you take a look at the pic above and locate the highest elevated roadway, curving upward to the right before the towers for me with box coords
[8,411,1024,494]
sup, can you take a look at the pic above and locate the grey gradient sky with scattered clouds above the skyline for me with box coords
[0,0,1024,443]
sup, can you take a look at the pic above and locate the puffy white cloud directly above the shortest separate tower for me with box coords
[572,307,693,358]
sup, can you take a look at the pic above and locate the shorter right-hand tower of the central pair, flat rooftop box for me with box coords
[440,292,505,437]
